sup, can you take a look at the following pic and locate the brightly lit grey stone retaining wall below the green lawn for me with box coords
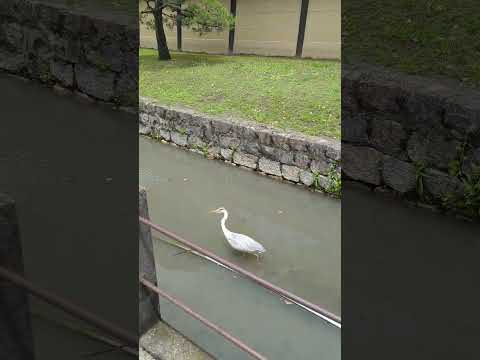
[139,98,340,192]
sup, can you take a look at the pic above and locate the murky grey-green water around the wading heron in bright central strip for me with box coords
[140,138,341,360]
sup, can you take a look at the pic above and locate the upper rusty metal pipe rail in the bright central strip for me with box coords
[139,216,341,328]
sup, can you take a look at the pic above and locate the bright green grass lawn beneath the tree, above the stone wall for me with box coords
[140,49,341,139]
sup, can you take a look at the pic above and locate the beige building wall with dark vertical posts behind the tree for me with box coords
[140,0,341,59]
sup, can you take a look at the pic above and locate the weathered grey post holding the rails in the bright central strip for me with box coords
[138,188,160,336]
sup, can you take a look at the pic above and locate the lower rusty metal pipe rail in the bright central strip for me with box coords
[140,277,267,360]
